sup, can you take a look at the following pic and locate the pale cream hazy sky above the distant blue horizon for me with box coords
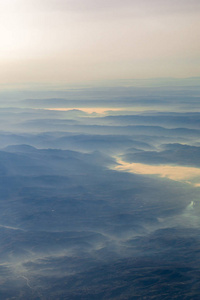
[0,0,200,85]
